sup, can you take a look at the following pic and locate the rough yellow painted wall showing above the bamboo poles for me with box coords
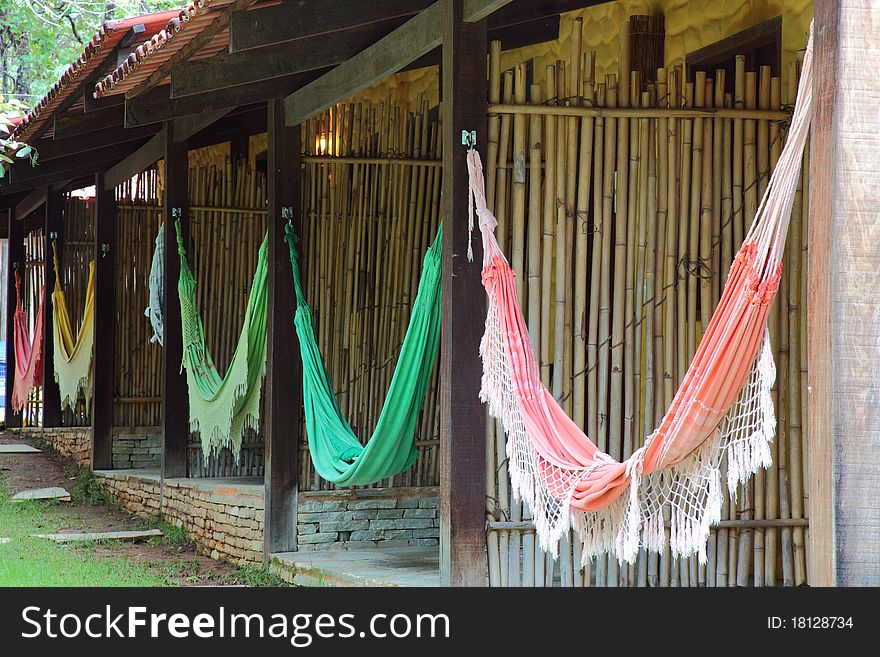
[348,0,813,107]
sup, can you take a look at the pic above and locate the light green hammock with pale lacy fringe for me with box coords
[174,221,269,458]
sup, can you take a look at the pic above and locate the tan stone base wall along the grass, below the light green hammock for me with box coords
[95,471,264,564]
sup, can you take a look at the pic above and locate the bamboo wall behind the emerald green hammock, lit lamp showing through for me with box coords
[300,100,441,490]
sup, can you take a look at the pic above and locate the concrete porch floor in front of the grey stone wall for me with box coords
[270,547,440,586]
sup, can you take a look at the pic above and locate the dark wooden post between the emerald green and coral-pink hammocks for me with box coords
[440,0,488,586]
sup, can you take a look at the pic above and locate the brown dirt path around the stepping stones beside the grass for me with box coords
[0,432,241,586]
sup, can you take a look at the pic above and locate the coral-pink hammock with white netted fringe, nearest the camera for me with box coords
[468,23,812,564]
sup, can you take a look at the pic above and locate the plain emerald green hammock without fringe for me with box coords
[286,225,442,486]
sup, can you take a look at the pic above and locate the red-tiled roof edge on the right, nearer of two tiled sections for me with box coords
[95,0,270,98]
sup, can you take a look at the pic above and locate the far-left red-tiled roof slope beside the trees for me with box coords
[13,11,177,141]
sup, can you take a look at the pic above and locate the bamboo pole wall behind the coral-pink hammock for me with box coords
[486,21,808,586]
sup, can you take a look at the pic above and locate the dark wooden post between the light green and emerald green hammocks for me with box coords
[263,99,302,564]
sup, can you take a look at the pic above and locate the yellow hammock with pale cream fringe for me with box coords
[52,241,95,410]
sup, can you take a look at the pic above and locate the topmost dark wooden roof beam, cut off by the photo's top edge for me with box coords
[227,0,434,52]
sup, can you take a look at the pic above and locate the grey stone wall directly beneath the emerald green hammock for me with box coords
[297,487,440,551]
